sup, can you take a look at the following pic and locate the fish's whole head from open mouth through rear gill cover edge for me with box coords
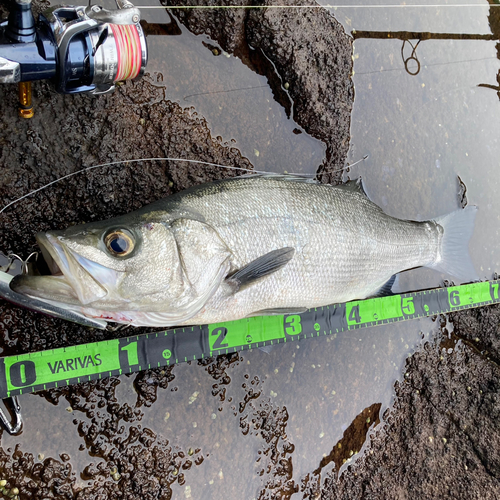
[10,213,232,326]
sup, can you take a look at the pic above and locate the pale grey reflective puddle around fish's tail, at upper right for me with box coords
[328,1,500,290]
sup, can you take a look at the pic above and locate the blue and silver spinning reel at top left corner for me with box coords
[0,0,147,118]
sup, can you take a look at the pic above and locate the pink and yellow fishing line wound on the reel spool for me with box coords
[110,24,142,82]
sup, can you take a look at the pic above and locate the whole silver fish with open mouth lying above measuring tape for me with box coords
[10,175,478,327]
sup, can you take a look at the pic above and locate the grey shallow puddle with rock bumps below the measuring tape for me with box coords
[2,319,435,499]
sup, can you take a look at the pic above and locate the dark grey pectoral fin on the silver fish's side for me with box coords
[226,247,295,293]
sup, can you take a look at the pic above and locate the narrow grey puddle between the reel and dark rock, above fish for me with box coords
[137,0,326,173]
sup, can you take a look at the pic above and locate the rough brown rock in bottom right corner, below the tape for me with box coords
[321,306,500,499]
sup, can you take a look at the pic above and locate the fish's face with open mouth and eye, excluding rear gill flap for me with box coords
[11,218,189,310]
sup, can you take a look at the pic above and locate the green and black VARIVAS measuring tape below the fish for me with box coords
[0,280,500,398]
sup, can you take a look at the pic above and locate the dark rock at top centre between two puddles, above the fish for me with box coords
[164,0,354,182]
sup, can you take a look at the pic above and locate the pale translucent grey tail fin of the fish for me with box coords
[428,206,479,281]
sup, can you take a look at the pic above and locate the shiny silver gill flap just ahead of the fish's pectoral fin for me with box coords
[170,219,232,296]
